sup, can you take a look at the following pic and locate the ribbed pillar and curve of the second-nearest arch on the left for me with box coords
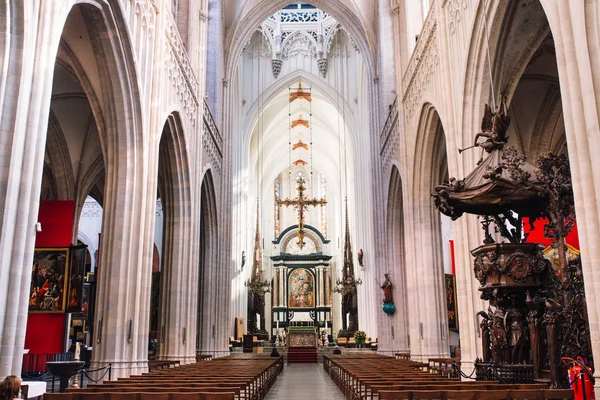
[158,113,197,363]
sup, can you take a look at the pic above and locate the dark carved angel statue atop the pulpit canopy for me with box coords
[473,94,510,153]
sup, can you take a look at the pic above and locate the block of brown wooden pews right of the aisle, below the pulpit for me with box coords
[323,354,573,400]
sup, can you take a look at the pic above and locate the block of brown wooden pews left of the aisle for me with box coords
[44,355,283,400]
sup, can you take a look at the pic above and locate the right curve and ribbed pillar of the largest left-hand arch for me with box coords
[53,0,153,376]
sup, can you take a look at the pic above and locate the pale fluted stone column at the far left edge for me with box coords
[0,0,64,379]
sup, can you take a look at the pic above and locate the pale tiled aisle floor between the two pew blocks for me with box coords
[265,364,344,400]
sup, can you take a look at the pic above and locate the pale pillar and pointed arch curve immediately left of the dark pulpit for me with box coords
[406,103,448,354]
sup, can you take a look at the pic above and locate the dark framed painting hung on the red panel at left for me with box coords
[29,247,70,313]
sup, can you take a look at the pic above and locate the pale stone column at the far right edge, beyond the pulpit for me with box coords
[541,0,600,387]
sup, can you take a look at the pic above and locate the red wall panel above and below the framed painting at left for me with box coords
[25,201,75,354]
